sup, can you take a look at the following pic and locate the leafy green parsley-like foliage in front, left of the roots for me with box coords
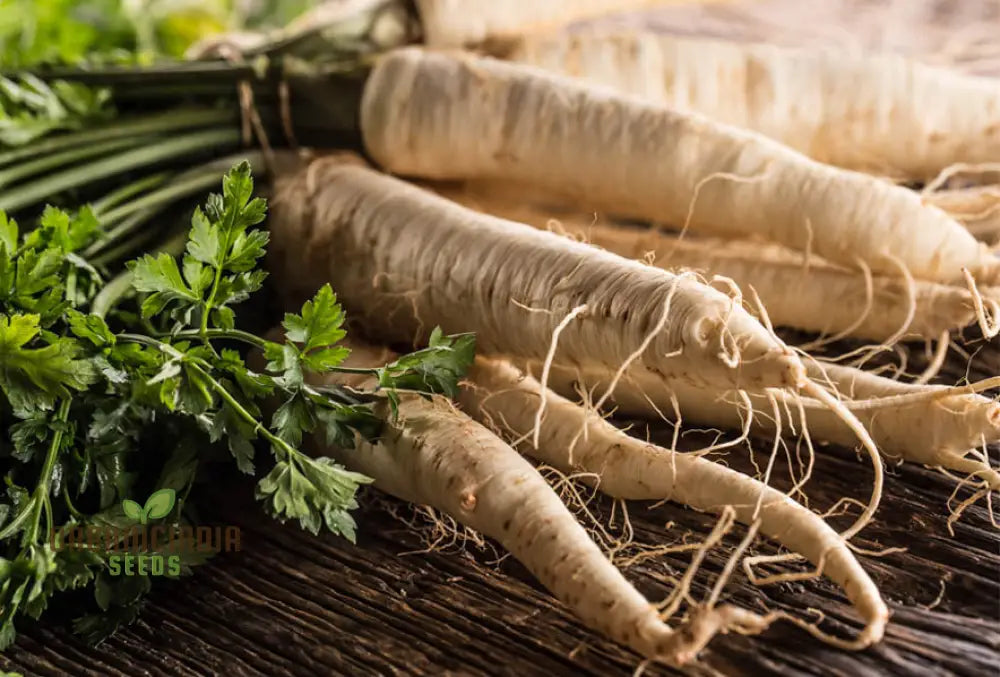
[0,163,474,648]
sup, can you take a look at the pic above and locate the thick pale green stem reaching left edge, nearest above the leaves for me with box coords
[0,129,240,212]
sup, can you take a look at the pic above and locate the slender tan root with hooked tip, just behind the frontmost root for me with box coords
[459,358,889,649]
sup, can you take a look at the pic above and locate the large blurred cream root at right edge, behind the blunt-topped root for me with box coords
[508,29,1000,180]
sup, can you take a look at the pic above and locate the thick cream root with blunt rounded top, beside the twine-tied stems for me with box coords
[361,48,998,284]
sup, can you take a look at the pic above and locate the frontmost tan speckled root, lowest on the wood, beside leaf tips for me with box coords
[302,344,765,665]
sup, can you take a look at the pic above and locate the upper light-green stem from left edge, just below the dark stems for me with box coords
[0,109,233,167]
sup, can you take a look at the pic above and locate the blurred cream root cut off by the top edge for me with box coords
[416,0,667,47]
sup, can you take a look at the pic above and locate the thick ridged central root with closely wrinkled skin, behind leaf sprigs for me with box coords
[270,161,804,387]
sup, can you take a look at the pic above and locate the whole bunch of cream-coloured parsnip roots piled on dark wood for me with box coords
[0,0,1000,664]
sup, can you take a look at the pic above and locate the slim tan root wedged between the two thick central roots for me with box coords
[433,185,976,341]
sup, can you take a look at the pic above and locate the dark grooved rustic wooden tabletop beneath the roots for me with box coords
[0,0,1000,677]
